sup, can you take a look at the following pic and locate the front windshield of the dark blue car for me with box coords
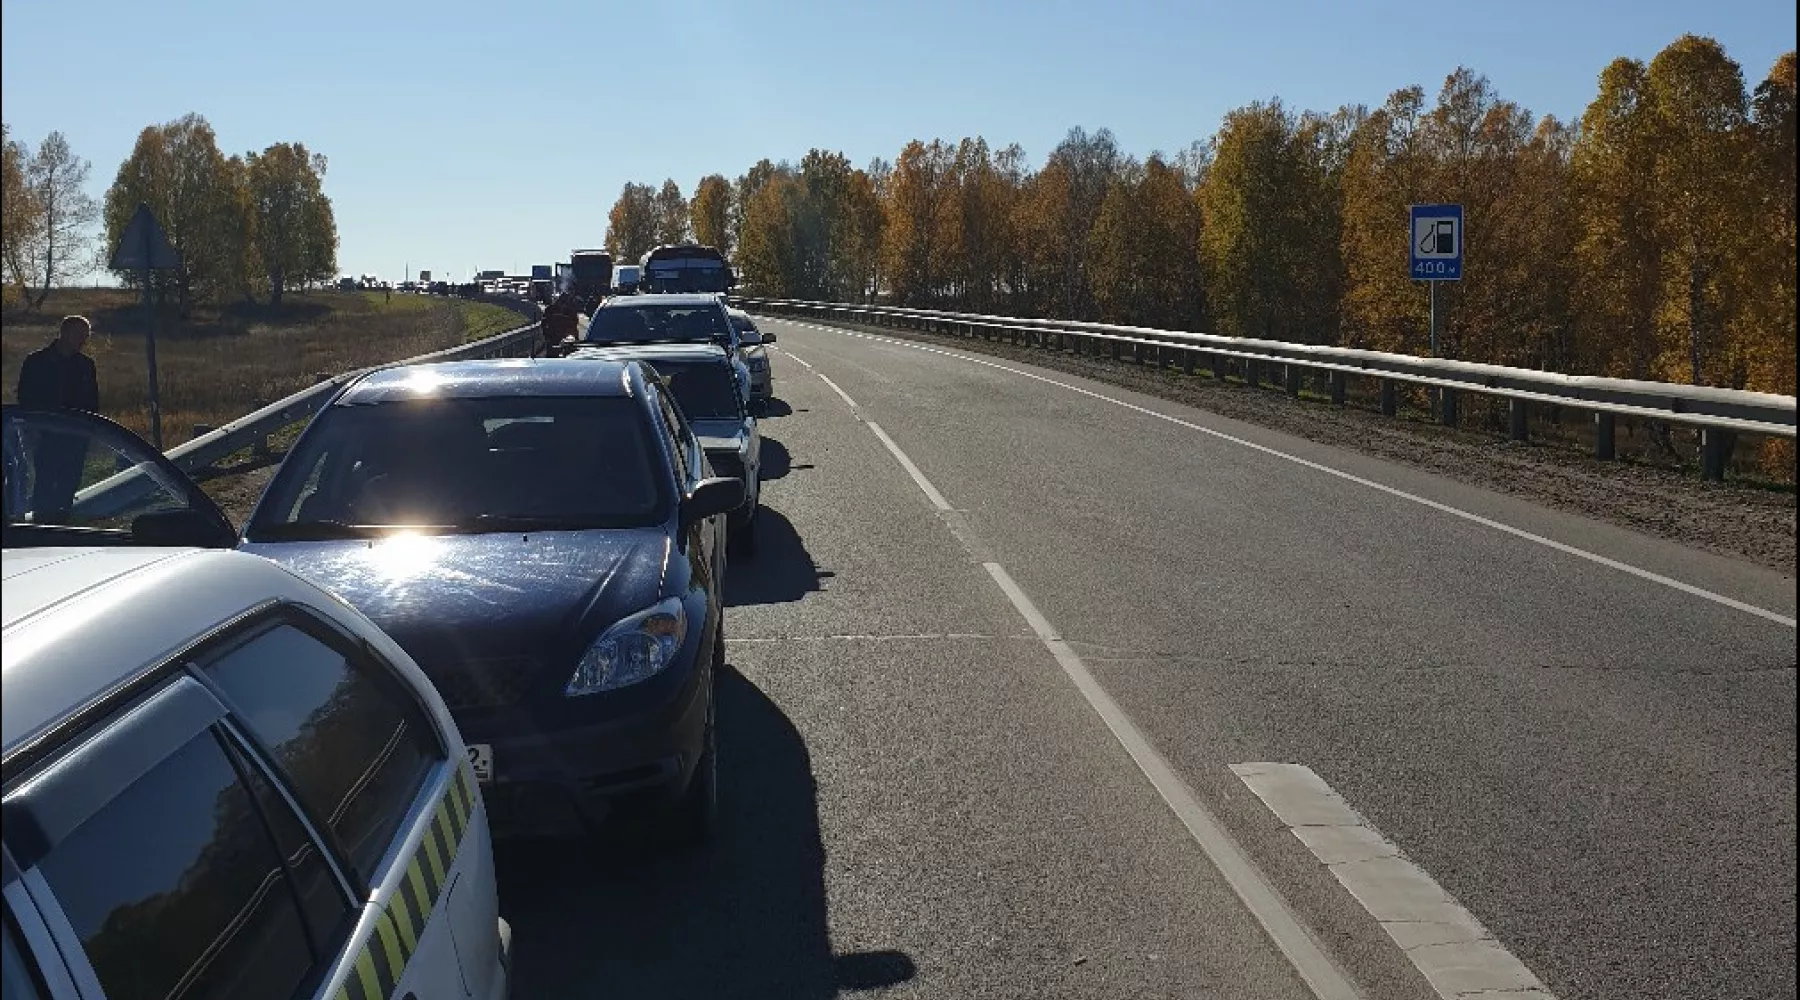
[247,397,670,541]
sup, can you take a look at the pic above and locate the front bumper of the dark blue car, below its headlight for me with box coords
[457,649,713,836]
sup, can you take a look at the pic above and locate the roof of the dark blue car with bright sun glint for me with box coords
[335,358,634,406]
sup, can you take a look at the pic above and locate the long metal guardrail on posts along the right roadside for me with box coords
[733,297,1796,480]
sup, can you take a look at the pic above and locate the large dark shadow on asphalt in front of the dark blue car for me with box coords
[495,667,916,1000]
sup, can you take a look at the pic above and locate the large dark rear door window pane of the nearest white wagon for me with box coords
[40,730,315,1000]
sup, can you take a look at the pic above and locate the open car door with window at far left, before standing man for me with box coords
[0,405,238,549]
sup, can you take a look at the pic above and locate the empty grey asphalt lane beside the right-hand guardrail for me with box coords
[769,320,1795,998]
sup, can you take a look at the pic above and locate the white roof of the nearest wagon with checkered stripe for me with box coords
[0,547,334,755]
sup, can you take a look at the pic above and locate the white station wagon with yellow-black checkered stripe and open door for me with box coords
[0,406,511,1000]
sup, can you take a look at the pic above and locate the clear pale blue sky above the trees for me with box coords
[0,0,1795,279]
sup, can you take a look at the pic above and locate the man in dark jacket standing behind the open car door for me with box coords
[18,317,101,523]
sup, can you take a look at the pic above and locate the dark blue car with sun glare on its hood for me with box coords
[243,360,745,838]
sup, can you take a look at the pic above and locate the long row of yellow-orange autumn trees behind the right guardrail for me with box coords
[607,36,1796,396]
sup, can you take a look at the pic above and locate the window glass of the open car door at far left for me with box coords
[0,408,208,531]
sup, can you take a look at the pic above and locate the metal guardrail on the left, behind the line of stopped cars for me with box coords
[76,322,542,518]
